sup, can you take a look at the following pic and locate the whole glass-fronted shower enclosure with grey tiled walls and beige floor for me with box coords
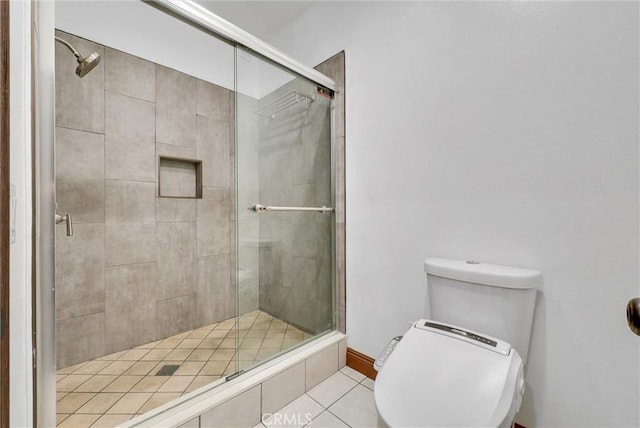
[47,2,336,425]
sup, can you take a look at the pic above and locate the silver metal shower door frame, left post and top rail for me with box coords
[32,0,336,427]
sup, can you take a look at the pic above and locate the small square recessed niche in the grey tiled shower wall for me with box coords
[158,156,202,199]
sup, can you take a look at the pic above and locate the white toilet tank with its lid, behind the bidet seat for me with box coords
[424,258,542,362]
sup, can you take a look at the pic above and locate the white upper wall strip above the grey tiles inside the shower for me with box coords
[55,0,291,98]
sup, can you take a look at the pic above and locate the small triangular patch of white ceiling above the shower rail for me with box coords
[196,0,313,40]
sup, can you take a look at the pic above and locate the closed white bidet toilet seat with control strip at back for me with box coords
[374,320,524,427]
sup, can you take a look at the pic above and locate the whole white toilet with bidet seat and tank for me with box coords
[374,258,542,428]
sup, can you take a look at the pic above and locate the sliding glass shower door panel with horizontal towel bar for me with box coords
[236,48,335,370]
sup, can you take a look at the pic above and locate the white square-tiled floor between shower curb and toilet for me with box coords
[254,367,378,428]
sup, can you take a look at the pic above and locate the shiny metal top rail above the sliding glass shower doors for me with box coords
[155,0,336,91]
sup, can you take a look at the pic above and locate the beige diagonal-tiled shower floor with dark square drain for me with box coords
[56,311,310,428]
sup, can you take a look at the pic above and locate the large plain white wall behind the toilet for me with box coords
[270,2,640,427]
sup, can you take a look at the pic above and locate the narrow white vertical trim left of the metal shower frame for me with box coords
[9,2,33,427]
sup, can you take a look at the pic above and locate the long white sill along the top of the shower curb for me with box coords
[118,331,347,428]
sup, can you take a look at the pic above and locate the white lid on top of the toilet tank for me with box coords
[424,257,542,289]
